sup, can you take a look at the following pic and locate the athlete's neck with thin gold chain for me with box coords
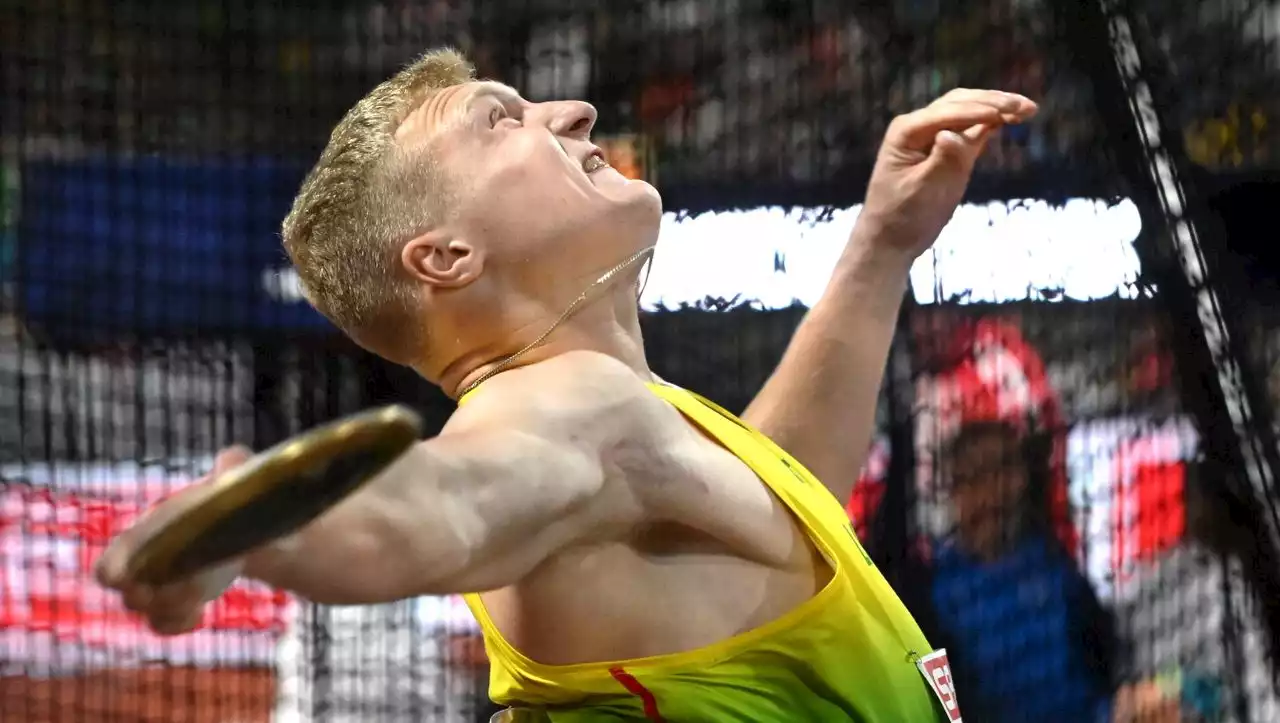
[435,280,653,399]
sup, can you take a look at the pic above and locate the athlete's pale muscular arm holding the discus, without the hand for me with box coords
[246,386,631,604]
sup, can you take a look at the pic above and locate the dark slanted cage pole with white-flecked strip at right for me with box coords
[1057,0,1280,720]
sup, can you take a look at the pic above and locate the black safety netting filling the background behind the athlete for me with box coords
[0,0,1280,723]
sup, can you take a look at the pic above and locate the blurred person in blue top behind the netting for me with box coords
[916,421,1115,723]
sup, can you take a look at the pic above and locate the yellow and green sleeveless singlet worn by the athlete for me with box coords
[466,384,943,723]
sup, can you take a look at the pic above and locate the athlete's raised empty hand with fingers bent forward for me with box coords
[858,88,1037,264]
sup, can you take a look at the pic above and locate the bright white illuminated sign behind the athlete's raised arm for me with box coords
[261,198,1142,311]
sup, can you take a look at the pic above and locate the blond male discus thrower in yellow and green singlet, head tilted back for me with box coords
[99,50,1036,723]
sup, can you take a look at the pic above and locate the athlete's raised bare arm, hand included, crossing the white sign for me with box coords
[744,88,1036,502]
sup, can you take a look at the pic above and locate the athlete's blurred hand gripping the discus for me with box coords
[93,447,251,635]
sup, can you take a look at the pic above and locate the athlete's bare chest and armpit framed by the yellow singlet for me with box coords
[485,399,831,664]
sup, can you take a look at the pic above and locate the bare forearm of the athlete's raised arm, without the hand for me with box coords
[742,223,910,502]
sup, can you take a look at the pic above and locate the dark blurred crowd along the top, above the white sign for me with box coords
[0,0,1280,182]
